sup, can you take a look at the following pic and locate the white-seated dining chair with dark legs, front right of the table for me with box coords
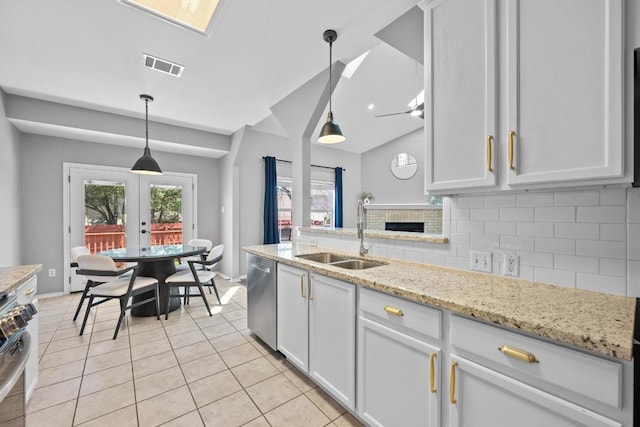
[164,245,224,320]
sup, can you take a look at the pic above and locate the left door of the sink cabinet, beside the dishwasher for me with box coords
[278,263,309,371]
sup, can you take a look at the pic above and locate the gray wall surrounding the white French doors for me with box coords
[20,135,220,294]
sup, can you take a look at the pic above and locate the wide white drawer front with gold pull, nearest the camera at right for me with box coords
[451,316,622,409]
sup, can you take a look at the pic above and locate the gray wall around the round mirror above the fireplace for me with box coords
[362,128,426,203]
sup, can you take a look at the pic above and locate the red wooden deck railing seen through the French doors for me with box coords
[84,222,182,254]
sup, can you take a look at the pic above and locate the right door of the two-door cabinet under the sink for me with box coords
[309,274,356,409]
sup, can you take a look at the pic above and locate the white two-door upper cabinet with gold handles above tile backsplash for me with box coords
[424,0,625,194]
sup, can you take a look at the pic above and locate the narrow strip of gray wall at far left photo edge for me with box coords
[0,90,24,266]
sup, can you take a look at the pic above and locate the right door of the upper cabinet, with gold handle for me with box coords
[502,0,624,185]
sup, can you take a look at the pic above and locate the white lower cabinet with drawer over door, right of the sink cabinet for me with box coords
[358,289,441,427]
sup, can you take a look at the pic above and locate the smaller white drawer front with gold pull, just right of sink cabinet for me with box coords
[358,288,442,340]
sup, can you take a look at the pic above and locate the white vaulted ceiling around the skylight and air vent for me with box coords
[0,0,423,152]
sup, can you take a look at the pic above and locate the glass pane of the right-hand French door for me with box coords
[149,184,183,246]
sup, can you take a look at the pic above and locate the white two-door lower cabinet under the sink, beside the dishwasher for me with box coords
[278,263,356,410]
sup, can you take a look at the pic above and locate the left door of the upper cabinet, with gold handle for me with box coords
[424,0,498,192]
